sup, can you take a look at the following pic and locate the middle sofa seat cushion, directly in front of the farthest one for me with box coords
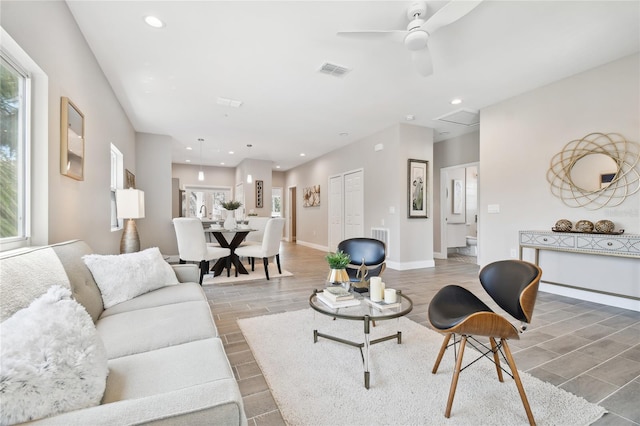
[96,301,217,359]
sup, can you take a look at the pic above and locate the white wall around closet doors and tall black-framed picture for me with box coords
[285,124,434,269]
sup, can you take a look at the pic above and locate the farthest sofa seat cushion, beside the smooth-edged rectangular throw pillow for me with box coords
[100,283,207,318]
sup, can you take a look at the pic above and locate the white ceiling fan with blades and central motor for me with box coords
[338,0,482,77]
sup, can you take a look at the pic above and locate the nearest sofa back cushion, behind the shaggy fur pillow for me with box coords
[0,247,69,321]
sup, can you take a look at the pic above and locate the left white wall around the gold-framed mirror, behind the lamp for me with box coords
[0,1,136,253]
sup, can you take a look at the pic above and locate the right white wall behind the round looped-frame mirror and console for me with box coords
[478,54,640,306]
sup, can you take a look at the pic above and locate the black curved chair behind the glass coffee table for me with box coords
[338,237,387,290]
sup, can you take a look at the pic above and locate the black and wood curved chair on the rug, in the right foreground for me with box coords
[428,259,542,425]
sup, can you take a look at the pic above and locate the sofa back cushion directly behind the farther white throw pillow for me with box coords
[51,240,104,323]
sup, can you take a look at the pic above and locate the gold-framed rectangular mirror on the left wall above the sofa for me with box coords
[60,97,84,180]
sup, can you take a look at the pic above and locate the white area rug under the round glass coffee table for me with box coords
[238,309,605,425]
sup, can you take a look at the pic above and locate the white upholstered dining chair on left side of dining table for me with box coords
[173,217,231,285]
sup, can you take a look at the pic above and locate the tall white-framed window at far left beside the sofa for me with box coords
[0,51,30,243]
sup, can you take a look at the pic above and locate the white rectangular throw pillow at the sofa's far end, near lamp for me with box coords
[82,247,178,309]
